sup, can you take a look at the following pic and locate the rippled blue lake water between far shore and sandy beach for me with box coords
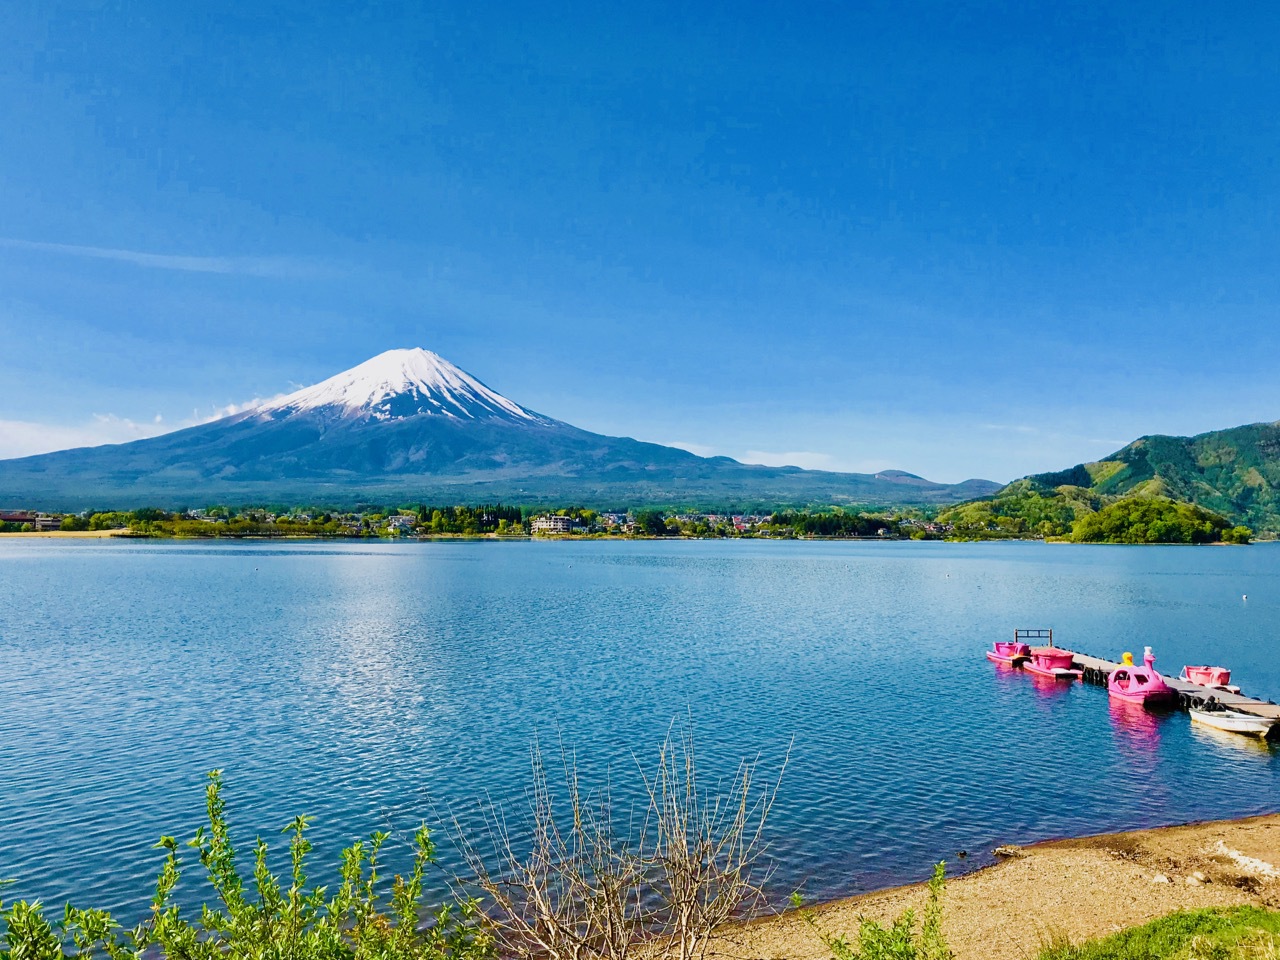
[0,540,1280,916]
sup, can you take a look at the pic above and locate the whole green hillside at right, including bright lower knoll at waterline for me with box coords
[938,422,1280,543]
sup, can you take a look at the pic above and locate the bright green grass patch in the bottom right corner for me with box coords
[1038,906,1280,960]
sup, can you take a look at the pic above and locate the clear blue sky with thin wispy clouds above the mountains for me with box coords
[0,0,1280,480]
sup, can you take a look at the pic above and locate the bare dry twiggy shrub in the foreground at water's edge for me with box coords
[454,724,786,960]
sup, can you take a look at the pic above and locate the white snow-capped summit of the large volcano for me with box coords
[256,347,544,422]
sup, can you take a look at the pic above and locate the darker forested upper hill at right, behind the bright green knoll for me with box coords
[1027,422,1280,532]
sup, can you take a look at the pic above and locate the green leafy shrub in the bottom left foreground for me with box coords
[0,771,494,960]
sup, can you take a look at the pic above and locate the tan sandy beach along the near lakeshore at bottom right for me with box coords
[714,814,1280,960]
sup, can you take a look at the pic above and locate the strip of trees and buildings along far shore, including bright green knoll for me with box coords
[0,495,1274,544]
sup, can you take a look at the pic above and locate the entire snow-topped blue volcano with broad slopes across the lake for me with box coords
[0,349,1000,509]
